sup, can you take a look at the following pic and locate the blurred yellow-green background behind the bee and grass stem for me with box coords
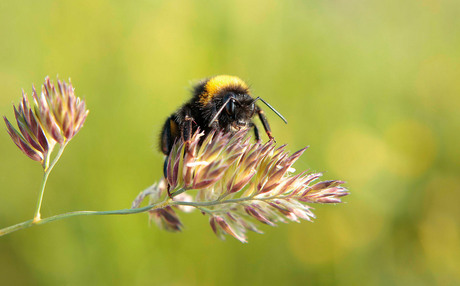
[0,0,460,285]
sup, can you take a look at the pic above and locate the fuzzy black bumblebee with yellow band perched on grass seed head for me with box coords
[160,75,287,156]
